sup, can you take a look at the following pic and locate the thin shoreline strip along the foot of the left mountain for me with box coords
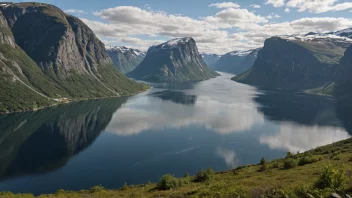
[0,84,153,116]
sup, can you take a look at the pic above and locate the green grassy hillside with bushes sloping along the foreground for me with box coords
[0,139,352,198]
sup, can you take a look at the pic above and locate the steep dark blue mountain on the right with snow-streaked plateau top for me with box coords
[233,34,352,90]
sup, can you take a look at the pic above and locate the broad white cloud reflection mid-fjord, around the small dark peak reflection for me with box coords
[106,73,264,135]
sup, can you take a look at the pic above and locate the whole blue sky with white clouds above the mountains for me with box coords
[15,0,352,55]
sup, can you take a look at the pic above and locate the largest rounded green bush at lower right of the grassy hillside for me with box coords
[315,165,346,190]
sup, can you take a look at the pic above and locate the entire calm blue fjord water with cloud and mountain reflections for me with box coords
[0,74,352,194]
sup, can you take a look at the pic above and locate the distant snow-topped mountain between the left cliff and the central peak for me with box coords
[106,46,145,74]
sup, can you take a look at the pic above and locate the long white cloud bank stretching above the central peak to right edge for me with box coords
[82,6,352,54]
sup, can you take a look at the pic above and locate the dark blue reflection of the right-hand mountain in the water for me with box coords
[254,90,342,127]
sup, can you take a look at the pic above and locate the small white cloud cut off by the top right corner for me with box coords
[286,0,352,13]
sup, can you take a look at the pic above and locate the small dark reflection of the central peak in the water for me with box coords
[150,90,197,105]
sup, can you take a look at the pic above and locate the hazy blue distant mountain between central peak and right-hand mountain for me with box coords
[214,48,260,74]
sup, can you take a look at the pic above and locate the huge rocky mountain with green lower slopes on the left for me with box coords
[0,3,145,113]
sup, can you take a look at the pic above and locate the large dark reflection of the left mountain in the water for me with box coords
[0,98,127,180]
